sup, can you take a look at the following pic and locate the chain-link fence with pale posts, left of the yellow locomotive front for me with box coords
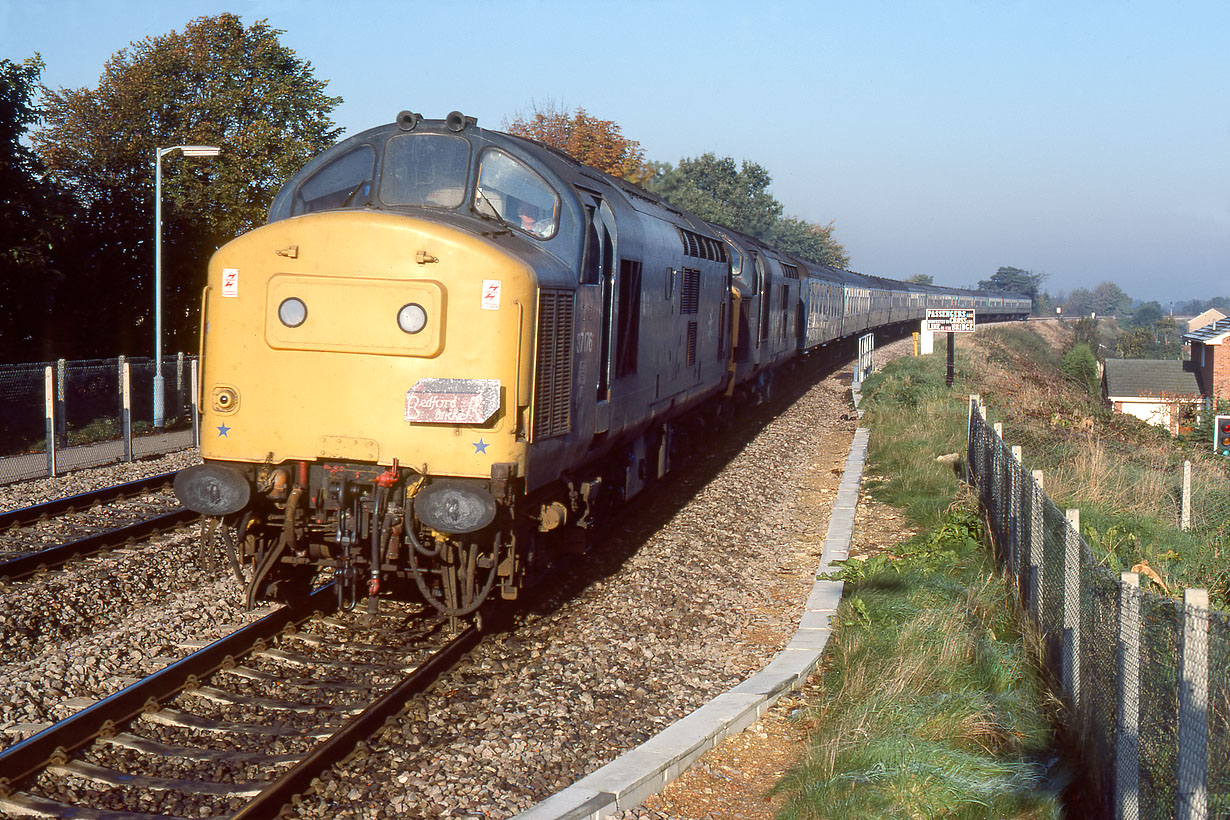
[0,353,199,484]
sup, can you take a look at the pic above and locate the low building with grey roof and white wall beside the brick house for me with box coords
[1102,358,1200,435]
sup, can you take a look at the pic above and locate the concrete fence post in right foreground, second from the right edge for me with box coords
[1114,573,1140,820]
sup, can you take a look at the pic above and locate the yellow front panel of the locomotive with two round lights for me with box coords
[202,211,535,478]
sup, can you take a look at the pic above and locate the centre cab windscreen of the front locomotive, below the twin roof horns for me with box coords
[380,134,470,208]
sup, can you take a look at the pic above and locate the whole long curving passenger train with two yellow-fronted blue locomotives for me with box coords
[175,111,1031,618]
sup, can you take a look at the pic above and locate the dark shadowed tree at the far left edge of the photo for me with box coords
[0,54,68,361]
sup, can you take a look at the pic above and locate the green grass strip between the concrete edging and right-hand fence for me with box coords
[774,357,1063,820]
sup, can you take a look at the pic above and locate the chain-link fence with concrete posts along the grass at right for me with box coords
[967,396,1230,820]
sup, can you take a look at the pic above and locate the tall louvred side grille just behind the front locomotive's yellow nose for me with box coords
[534,290,573,439]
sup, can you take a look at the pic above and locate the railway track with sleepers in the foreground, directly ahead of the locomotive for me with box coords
[0,586,478,820]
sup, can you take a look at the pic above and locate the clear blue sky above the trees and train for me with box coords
[0,0,1230,305]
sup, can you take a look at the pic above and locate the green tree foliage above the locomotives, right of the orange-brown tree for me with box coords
[646,154,850,267]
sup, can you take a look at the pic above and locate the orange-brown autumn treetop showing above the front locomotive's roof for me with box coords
[503,102,653,184]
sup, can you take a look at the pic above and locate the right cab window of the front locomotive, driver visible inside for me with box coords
[474,149,560,240]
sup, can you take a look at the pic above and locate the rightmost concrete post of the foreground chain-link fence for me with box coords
[1175,589,1209,820]
